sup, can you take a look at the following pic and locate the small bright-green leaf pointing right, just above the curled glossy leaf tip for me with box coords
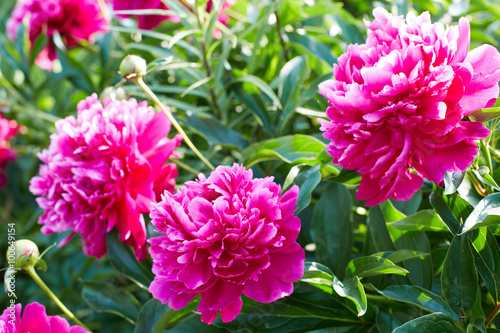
[345,256,408,279]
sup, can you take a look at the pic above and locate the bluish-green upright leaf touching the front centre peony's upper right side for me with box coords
[287,165,321,215]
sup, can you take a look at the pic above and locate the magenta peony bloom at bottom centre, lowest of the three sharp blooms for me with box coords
[149,164,304,324]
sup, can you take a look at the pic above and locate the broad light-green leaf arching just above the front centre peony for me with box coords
[241,134,325,168]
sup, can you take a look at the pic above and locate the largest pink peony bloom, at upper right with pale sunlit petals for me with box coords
[319,8,500,206]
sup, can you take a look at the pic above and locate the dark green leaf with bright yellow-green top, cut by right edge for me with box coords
[469,227,500,302]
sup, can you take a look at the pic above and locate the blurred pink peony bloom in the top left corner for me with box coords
[7,0,109,71]
